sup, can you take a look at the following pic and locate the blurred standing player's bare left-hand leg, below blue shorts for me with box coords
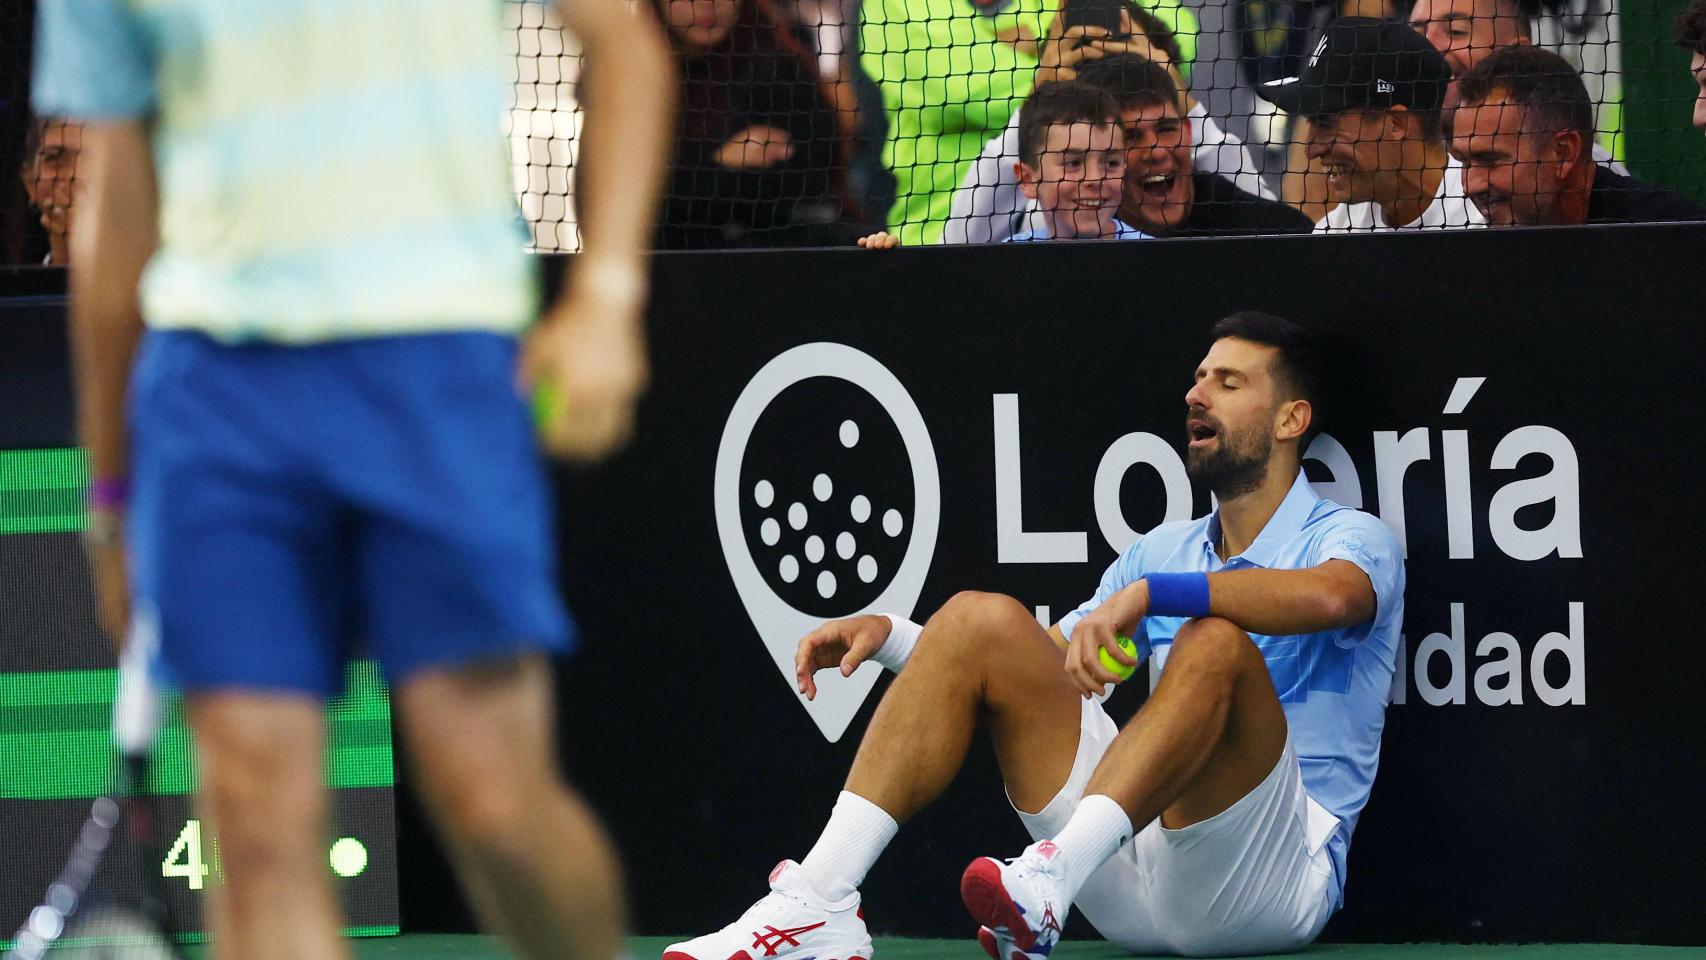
[184,691,350,960]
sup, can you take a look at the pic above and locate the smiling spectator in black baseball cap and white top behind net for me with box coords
[1256,17,1484,232]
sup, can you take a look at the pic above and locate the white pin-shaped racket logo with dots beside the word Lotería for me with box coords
[713,343,942,740]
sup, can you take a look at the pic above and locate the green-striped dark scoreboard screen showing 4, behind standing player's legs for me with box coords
[0,450,397,950]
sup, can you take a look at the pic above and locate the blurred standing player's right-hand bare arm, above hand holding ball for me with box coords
[565,0,676,308]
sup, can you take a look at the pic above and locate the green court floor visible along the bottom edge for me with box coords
[173,933,1706,960]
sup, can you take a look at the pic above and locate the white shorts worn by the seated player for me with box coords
[1015,701,1339,957]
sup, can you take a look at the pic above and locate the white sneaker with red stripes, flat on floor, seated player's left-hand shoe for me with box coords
[662,859,872,960]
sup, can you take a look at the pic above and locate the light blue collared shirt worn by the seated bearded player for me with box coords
[1059,471,1404,904]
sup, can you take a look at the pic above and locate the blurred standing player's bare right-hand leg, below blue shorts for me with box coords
[397,656,626,960]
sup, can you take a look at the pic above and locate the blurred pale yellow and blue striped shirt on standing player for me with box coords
[34,0,539,343]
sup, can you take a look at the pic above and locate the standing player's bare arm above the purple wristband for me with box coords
[70,123,157,479]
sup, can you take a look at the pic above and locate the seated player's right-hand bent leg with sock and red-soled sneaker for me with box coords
[960,617,1286,960]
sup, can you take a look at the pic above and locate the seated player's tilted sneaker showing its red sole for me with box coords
[960,841,1071,960]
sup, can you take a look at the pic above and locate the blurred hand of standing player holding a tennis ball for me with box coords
[520,280,652,462]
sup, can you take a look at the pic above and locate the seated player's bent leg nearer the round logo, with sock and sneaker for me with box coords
[664,593,1080,960]
